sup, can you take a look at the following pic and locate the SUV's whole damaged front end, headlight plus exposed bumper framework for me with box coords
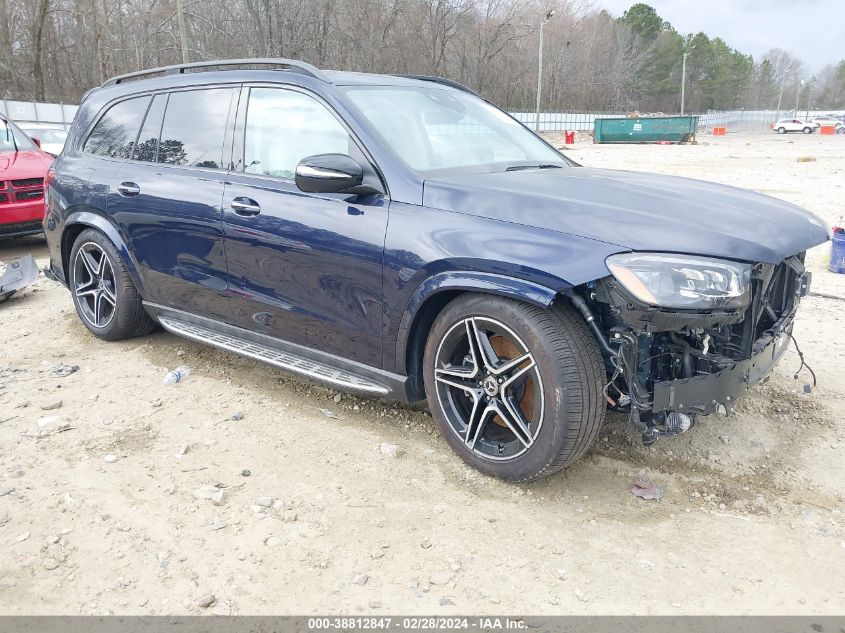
[570,252,811,445]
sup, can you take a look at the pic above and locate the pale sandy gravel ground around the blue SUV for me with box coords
[0,134,845,615]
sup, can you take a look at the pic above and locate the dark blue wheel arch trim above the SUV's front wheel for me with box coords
[396,271,571,401]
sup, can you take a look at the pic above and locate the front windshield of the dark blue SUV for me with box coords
[346,86,567,172]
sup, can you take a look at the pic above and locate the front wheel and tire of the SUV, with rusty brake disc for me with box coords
[423,294,607,482]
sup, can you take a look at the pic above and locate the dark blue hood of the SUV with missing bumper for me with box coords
[423,167,828,264]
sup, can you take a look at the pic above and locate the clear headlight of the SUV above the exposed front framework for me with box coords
[606,253,751,309]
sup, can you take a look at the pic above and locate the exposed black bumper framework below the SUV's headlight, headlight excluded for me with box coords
[588,256,812,444]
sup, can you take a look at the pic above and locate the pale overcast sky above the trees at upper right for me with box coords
[593,0,845,72]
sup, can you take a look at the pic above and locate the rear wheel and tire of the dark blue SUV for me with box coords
[68,229,155,341]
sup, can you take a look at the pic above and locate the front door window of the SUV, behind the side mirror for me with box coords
[244,88,352,179]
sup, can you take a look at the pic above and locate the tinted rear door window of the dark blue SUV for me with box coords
[156,88,234,169]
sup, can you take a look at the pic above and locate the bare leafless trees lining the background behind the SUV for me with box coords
[0,0,845,111]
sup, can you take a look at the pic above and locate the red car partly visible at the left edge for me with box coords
[0,115,53,238]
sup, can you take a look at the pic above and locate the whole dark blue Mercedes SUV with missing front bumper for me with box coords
[45,60,828,481]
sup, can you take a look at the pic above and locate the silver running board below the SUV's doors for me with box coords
[158,316,390,396]
